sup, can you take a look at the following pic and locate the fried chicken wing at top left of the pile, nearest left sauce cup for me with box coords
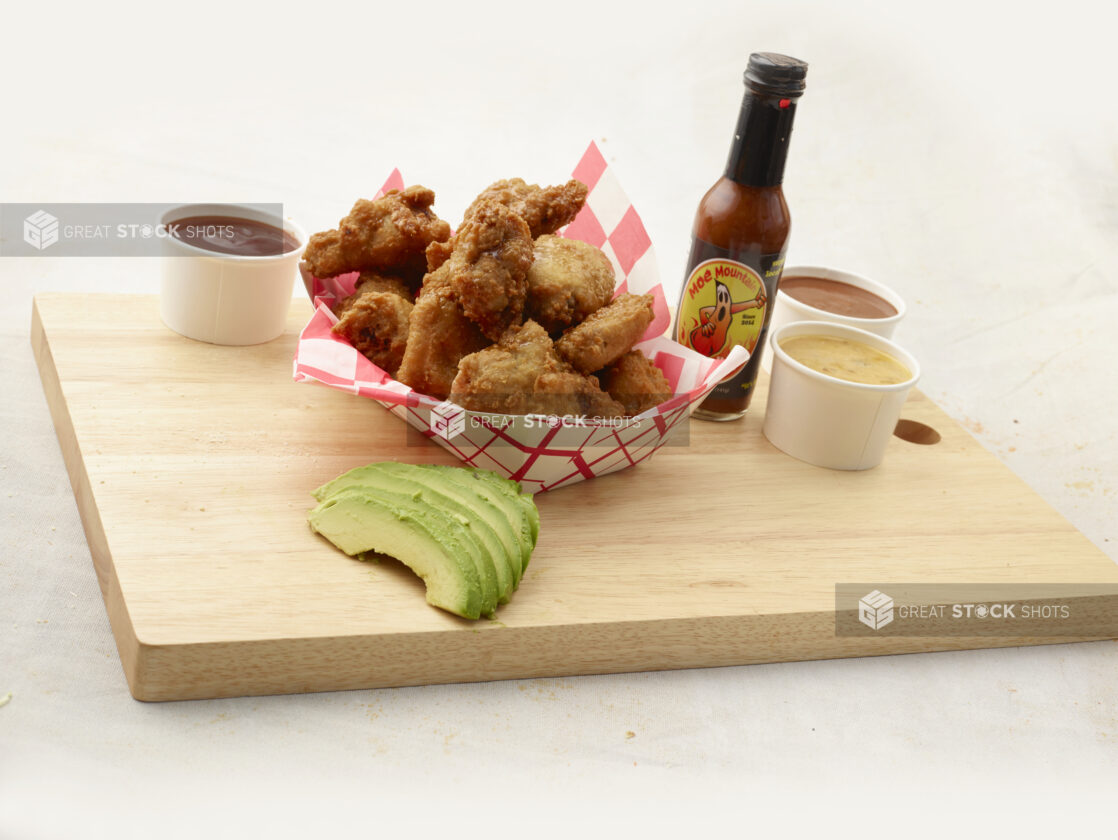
[303,186,451,277]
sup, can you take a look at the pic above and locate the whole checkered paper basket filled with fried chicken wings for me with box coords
[294,144,748,492]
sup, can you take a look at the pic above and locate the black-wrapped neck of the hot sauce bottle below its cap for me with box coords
[726,88,796,187]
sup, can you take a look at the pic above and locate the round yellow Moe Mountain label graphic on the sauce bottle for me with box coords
[675,259,768,359]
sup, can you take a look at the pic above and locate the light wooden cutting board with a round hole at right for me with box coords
[31,294,1118,700]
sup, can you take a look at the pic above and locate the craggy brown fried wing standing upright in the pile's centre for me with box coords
[423,201,532,341]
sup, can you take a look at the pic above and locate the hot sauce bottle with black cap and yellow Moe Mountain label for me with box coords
[675,53,807,421]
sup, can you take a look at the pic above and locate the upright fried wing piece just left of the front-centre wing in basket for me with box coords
[396,286,490,399]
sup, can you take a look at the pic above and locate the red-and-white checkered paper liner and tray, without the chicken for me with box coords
[294,142,749,493]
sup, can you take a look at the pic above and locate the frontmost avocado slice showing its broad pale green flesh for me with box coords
[307,487,492,619]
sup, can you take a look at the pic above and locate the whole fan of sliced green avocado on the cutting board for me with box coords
[307,461,540,619]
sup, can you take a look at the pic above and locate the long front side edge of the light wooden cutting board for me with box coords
[124,613,1118,701]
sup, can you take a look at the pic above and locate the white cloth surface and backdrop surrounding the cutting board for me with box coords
[0,0,1118,840]
